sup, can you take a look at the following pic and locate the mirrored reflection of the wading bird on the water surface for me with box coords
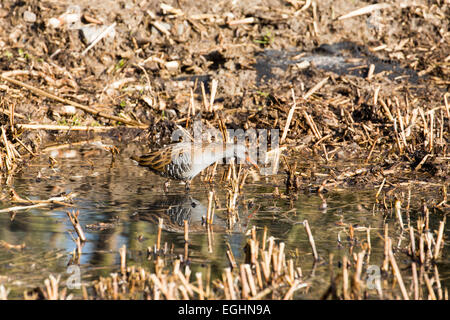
[134,195,225,232]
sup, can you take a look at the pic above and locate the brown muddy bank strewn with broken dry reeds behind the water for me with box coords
[0,1,449,188]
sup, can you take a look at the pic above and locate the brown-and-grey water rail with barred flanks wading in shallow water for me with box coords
[132,142,258,189]
